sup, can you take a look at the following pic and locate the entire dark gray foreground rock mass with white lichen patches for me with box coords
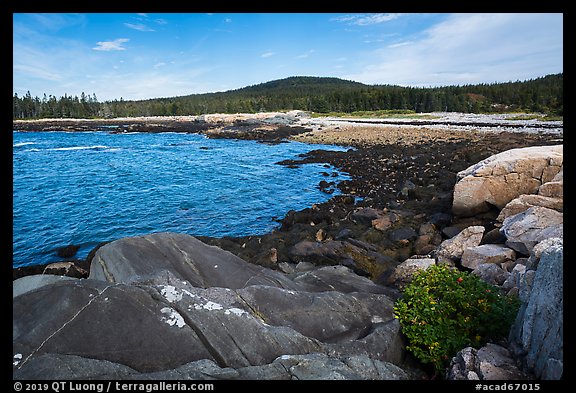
[13,233,408,379]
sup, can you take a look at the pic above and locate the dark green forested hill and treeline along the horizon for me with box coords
[13,74,563,119]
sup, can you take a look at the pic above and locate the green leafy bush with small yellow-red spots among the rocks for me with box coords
[394,265,520,374]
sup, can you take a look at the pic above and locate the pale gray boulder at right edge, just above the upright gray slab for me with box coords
[500,206,564,255]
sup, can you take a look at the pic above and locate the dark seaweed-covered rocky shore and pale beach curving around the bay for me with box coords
[13,111,562,282]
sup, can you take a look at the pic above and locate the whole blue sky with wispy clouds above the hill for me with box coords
[13,13,563,101]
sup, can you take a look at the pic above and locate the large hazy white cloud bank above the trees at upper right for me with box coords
[345,13,563,86]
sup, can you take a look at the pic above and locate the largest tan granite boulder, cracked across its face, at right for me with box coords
[452,145,563,216]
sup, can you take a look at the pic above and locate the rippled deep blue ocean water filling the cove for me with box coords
[13,131,347,267]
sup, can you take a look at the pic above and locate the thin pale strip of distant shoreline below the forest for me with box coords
[13,111,564,142]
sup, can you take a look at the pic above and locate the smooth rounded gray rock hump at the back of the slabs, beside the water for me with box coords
[89,232,300,288]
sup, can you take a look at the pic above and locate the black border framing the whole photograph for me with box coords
[6,0,576,393]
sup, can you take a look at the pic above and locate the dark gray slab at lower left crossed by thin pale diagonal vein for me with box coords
[12,280,213,372]
